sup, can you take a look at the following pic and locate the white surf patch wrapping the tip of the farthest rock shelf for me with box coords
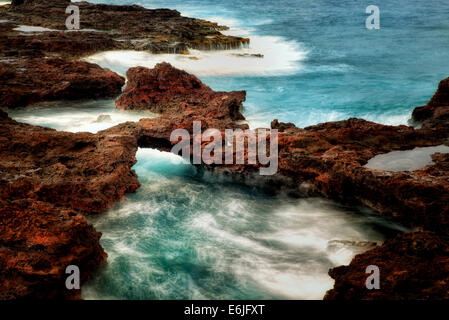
[85,29,307,76]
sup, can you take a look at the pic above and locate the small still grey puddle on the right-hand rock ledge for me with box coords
[365,145,449,171]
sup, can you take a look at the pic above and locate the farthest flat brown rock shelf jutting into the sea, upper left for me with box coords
[0,0,249,56]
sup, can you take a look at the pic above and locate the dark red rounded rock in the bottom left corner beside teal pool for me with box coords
[0,199,106,300]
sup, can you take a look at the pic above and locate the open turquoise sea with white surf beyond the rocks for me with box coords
[87,0,449,127]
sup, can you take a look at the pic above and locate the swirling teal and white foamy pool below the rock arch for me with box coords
[83,149,402,299]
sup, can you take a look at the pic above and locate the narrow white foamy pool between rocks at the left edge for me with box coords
[8,100,156,133]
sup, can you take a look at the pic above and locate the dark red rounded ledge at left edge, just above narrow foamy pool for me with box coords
[0,58,125,108]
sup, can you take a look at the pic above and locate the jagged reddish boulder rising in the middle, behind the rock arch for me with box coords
[116,63,246,129]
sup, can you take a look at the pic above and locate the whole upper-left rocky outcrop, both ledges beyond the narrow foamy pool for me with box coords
[0,0,249,108]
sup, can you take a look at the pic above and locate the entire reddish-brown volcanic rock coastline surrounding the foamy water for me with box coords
[0,0,449,299]
